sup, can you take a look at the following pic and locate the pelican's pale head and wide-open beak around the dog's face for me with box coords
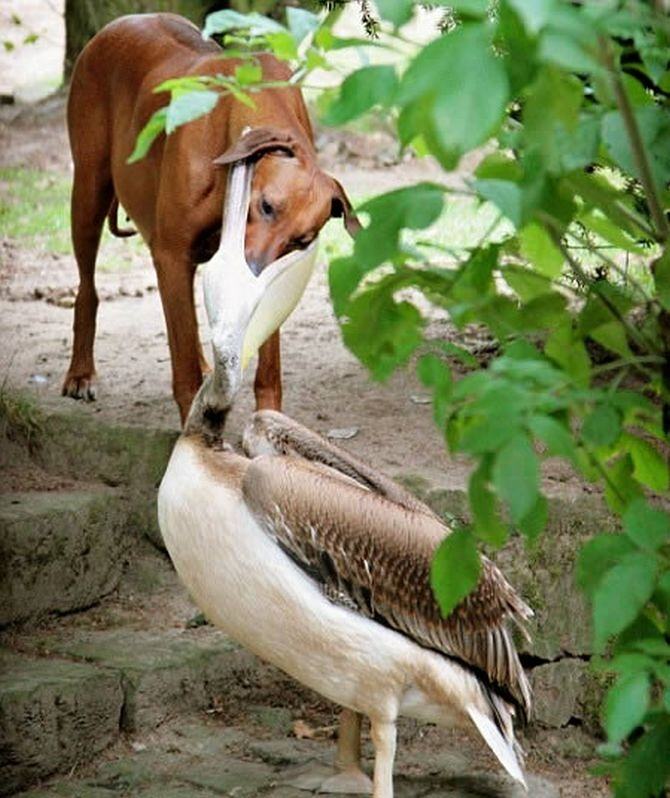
[197,161,317,410]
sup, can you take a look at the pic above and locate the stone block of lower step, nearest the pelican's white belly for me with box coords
[42,628,258,732]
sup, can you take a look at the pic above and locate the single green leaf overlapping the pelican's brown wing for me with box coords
[430,529,481,618]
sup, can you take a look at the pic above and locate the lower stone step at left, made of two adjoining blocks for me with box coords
[0,627,262,795]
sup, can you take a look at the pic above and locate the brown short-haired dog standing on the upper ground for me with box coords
[63,14,358,422]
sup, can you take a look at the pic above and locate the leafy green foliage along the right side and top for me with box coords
[136,0,670,798]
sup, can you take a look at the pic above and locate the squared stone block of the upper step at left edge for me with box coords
[0,488,130,625]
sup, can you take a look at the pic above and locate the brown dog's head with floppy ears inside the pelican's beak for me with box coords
[214,127,360,274]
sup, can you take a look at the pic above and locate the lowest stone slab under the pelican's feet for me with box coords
[13,717,564,798]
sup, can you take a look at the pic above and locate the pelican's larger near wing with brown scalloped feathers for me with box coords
[242,456,532,716]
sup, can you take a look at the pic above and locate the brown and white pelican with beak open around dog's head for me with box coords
[158,159,532,798]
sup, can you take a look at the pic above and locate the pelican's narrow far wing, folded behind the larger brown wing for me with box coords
[243,410,437,518]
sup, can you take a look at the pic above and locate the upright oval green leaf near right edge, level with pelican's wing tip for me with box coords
[593,553,657,652]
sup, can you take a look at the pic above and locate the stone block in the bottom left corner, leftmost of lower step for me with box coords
[0,651,123,798]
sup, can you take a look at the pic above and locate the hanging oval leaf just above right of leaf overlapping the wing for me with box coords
[493,434,540,524]
